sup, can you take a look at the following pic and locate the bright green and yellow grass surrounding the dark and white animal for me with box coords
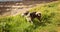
[0,2,60,32]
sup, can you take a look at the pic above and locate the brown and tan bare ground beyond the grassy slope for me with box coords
[0,1,57,16]
